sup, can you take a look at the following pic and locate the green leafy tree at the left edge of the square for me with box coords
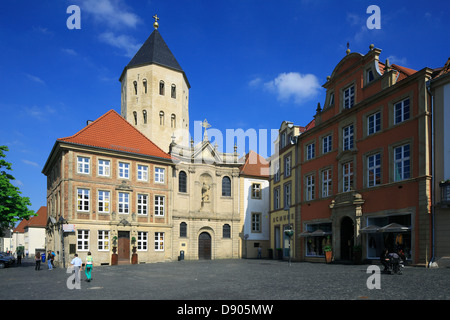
[0,146,35,236]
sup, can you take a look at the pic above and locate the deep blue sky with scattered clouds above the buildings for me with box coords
[0,0,450,215]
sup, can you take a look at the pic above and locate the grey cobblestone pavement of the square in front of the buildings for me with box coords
[0,259,450,300]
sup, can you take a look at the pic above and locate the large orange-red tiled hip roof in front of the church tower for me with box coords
[58,110,171,159]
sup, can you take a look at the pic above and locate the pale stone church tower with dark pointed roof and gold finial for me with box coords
[119,15,190,152]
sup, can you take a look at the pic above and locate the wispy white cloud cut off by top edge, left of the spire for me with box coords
[81,0,141,28]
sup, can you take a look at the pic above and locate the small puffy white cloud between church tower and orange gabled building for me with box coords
[264,72,321,104]
